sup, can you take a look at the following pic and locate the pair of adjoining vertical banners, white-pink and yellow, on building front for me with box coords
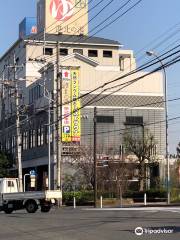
[62,69,81,142]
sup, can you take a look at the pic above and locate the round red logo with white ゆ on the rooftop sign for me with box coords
[50,0,73,21]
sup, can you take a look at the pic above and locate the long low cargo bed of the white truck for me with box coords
[2,190,62,200]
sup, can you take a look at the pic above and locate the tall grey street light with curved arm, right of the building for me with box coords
[146,51,170,204]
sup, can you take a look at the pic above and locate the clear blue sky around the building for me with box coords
[0,0,180,153]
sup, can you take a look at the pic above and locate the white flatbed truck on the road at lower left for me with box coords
[0,178,62,214]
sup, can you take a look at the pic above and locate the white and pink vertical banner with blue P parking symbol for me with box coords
[62,69,71,142]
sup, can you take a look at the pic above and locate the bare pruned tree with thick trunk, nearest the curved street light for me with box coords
[123,126,156,191]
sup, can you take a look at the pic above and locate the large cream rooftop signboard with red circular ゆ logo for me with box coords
[37,0,88,35]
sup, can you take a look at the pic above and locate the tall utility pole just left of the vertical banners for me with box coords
[55,42,62,202]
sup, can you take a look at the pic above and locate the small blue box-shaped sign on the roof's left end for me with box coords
[19,17,37,38]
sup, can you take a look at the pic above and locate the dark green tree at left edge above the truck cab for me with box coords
[0,151,12,178]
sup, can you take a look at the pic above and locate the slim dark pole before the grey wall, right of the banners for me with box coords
[94,107,97,208]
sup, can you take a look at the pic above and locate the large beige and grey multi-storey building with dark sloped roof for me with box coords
[0,1,165,189]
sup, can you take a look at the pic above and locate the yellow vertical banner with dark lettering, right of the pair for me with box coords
[71,70,81,142]
